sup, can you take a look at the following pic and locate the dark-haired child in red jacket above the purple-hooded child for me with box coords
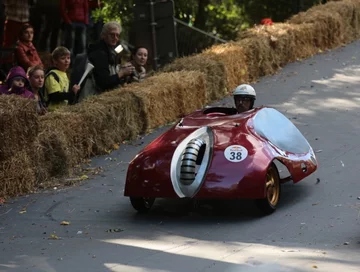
[15,24,43,70]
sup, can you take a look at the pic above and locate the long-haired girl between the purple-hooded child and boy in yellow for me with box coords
[27,65,47,115]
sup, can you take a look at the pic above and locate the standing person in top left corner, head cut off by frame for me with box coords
[3,0,30,47]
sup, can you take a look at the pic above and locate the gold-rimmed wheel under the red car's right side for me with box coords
[256,163,281,215]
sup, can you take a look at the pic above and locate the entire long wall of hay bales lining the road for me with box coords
[0,0,360,197]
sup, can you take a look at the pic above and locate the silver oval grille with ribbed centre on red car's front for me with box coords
[170,127,213,197]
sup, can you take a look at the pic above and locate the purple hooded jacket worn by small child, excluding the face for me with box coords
[0,66,35,98]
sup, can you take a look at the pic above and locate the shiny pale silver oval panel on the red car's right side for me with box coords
[254,108,311,154]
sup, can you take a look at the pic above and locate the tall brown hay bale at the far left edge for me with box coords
[0,95,39,197]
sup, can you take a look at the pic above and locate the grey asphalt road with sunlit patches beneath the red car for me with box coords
[0,41,360,272]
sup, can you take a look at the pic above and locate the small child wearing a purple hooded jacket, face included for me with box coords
[0,66,34,99]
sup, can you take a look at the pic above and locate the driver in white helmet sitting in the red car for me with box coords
[233,84,256,113]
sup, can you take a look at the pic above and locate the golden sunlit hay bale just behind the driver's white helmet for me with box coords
[202,42,249,93]
